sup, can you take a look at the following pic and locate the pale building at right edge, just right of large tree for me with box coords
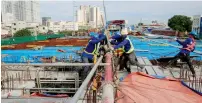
[192,15,202,37]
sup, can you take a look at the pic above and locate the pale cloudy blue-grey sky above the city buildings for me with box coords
[40,1,202,24]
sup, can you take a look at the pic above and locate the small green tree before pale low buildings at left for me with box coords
[14,29,32,37]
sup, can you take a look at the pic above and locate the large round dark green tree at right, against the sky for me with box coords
[168,15,192,32]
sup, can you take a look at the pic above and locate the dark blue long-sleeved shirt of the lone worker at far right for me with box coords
[176,38,195,54]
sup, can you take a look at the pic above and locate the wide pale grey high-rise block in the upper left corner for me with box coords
[1,0,41,22]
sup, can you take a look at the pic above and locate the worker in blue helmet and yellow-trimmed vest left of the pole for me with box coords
[81,32,104,79]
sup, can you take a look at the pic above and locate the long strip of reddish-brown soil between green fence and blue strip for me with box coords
[1,38,88,50]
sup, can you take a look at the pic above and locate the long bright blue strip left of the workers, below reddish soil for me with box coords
[1,47,81,63]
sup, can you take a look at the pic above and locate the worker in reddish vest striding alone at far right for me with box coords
[168,31,197,77]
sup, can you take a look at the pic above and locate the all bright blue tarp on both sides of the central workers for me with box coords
[1,37,202,63]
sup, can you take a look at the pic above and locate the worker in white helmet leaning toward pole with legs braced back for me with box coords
[110,28,143,73]
